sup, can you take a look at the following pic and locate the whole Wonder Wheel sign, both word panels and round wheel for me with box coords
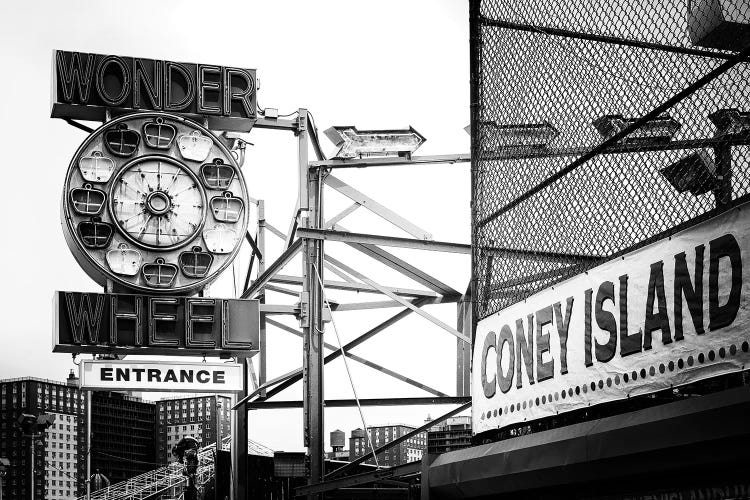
[52,52,259,366]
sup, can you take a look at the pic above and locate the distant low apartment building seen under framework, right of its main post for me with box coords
[349,424,427,467]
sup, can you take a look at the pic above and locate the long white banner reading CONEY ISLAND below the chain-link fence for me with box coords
[472,204,750,433]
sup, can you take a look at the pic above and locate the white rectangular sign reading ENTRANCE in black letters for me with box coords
[80,360,242,393]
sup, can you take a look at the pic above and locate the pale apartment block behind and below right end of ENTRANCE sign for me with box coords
[156,395,231,463]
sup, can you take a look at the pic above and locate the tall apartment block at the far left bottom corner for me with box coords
[0,377,87,500]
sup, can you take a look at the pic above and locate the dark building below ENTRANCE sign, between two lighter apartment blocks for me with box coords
[91,391,156,484]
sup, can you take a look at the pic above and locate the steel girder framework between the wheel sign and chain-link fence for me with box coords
[228,109,471,495]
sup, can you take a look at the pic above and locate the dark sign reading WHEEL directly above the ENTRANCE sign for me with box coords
[52,292,260,356]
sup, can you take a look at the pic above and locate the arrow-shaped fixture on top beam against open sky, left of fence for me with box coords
[324,125,426,159]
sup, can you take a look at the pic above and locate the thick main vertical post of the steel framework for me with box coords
[297,109,325,499]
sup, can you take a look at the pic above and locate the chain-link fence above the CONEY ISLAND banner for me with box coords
[470,0,750,320]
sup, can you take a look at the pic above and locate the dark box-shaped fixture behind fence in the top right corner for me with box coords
[687,0,750,52]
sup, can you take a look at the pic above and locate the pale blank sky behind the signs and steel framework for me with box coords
[0,0,470,451]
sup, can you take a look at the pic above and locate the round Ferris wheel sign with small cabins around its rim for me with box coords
[62,113,248,293]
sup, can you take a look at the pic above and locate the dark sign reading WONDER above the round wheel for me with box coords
[51,50,257,132]
